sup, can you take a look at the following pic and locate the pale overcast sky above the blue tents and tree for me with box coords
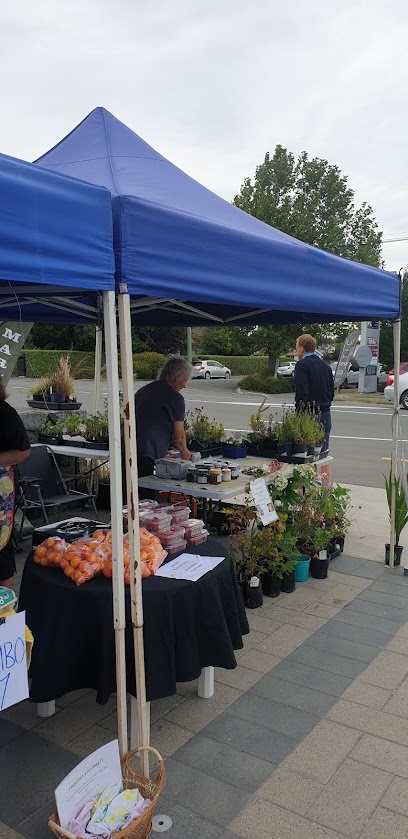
[0,0,408,270]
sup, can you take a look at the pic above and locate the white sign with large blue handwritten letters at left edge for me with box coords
[0,612,28,711]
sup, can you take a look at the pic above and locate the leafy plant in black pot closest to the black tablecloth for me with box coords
[229,498,265,609]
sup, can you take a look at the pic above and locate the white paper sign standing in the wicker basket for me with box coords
[55,740,122,830]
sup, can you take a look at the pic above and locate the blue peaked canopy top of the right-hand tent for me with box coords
[36,103,400,326]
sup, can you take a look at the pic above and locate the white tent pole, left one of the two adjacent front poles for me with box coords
[103,291,128,755]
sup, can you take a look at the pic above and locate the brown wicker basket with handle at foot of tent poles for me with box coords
[48,746,166,839]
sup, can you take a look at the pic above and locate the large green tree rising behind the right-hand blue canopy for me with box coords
[233,145,382,370]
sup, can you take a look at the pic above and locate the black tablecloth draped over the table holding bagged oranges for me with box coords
[19,539,249,704]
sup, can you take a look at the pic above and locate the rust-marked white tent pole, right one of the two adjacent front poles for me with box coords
[118,285,149,777]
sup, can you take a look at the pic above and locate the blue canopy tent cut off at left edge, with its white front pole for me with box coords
[0,155,132,752]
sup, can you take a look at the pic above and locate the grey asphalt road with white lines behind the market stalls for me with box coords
[8,379,408,487]
